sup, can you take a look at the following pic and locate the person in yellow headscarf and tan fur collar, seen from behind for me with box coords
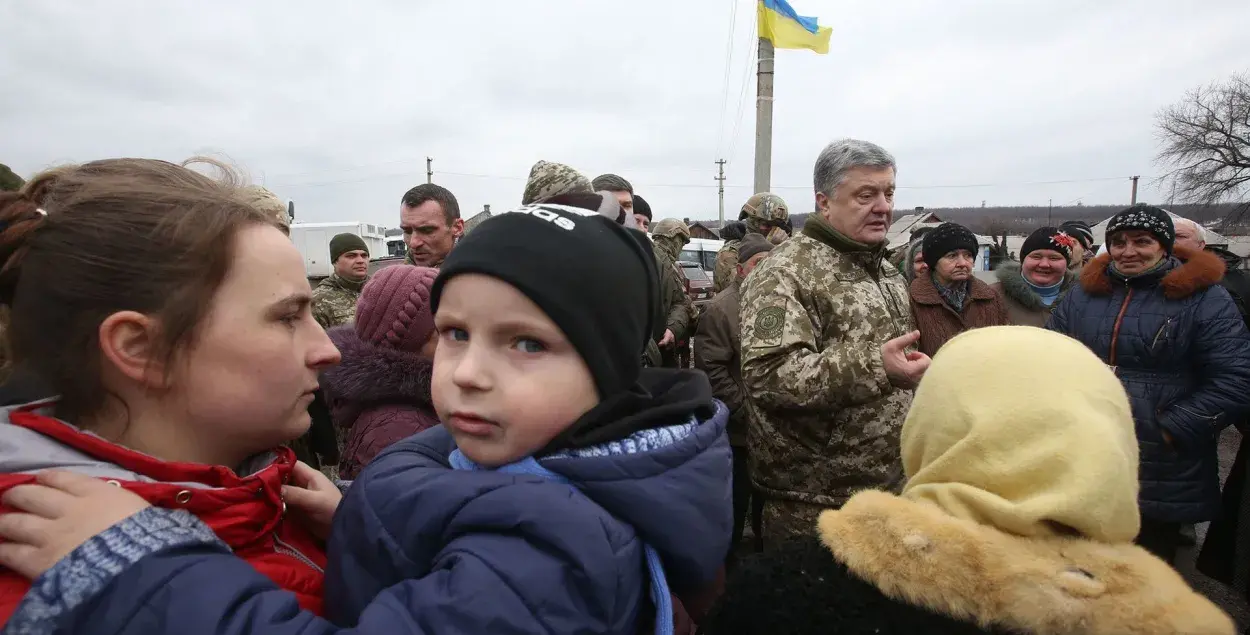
[705,326,1234,635]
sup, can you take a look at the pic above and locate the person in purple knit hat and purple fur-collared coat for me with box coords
[321,265,439,480]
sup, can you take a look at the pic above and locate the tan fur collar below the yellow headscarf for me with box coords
[819,491,1234,635]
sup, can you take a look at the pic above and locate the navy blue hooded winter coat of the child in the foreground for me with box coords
[5,375,733,635]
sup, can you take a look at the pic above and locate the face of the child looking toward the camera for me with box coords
[431,274,599,468]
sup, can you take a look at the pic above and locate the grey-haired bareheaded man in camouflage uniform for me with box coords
[741,141,928,544]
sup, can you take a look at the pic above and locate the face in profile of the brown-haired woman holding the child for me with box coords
[170,225,339,458]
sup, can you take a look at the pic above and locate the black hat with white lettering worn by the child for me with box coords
[433,205,660,400]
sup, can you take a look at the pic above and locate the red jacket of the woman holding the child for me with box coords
[0,404,325,624]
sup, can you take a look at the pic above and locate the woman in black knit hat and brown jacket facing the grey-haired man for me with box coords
[911,223,1011,356]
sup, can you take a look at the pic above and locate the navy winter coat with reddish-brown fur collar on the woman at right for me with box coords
[1045,246,1250,523]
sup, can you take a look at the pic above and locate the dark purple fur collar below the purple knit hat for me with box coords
[321,324,434,408]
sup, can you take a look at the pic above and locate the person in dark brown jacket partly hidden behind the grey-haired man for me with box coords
[695,234,773,559]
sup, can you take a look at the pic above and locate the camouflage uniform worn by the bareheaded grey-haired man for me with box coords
[741,215,914,540]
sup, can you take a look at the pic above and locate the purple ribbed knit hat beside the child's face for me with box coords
[355,265,439,353]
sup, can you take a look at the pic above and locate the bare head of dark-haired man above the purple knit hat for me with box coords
[399,183,465,268]
